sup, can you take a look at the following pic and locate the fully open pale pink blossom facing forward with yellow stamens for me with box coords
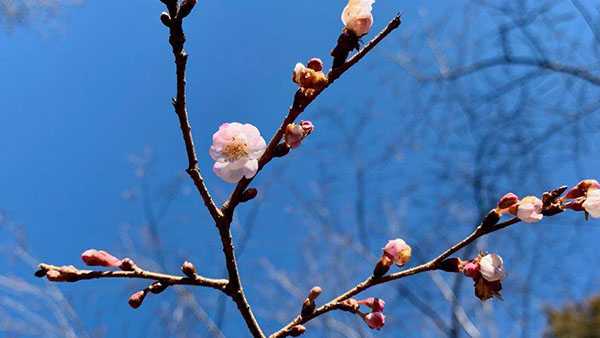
[209,122,267,183]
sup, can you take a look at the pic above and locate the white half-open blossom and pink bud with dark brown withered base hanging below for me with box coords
[458,254,506,300]
